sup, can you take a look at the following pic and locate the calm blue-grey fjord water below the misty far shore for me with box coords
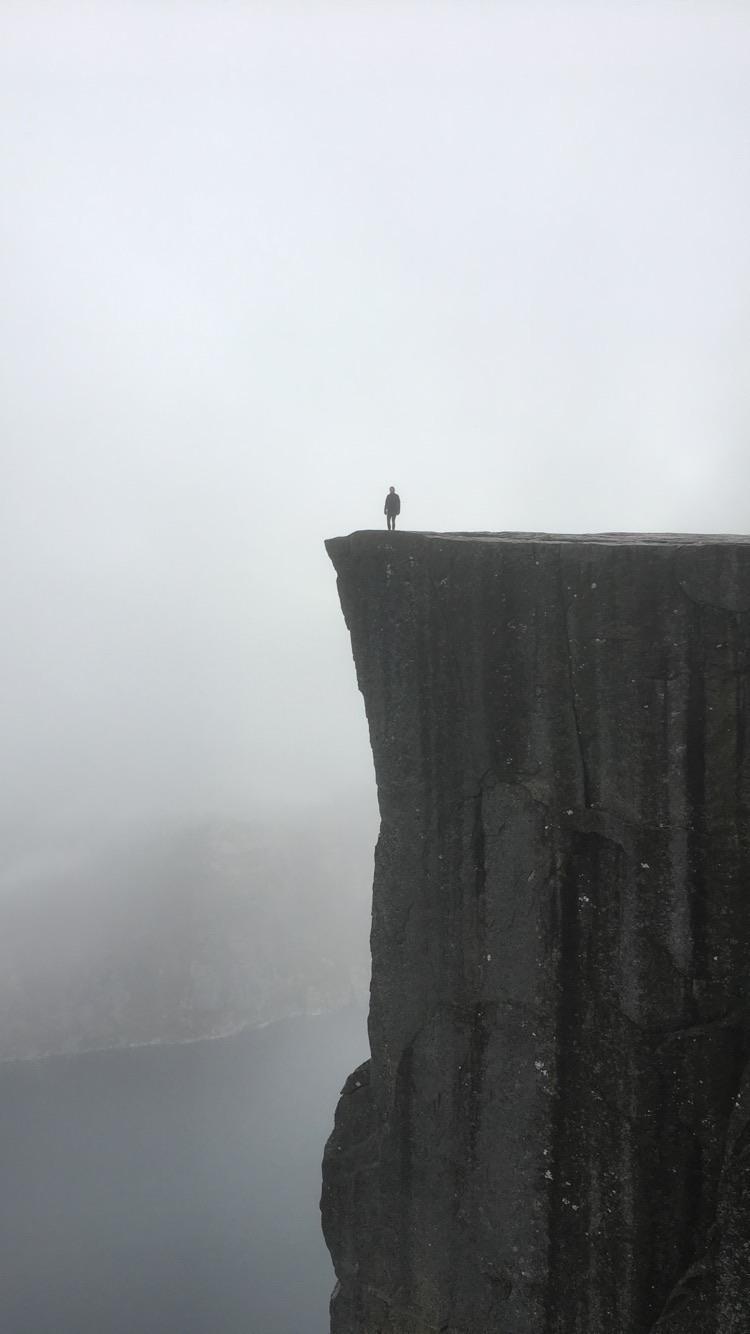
[0,1007,367,1334]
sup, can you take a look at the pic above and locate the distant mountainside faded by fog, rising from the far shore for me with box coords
[0,819,372,1061]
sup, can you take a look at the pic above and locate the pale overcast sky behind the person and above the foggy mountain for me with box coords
[0,0,750,822]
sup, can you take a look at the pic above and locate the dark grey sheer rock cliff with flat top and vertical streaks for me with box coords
[323,532,750,1334]
